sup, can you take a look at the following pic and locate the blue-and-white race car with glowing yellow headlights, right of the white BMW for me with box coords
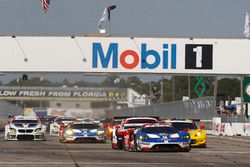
[60,121,106,143]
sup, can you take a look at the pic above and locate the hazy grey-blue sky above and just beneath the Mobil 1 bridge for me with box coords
[0,0,250,82]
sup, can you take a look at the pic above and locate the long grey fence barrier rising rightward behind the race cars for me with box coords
[107,97,217,120]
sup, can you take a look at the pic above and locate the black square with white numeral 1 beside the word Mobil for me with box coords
[185,44,213,69]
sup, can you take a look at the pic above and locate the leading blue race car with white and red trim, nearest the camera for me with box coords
[124,123,191,152]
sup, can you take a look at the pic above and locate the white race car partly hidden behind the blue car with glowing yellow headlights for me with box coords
[49,116,76,136]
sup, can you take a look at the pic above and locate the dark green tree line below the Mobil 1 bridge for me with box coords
[0,75,240,103]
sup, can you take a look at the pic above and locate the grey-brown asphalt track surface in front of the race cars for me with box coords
[0,133,250,167]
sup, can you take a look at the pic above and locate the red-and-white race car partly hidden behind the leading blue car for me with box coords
[111,117,158,150]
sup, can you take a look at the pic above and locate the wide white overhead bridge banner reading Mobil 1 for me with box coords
[0,36,250,74]
